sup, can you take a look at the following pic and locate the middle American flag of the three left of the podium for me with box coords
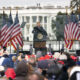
[3,11,14,47]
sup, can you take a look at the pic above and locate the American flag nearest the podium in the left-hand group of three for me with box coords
[11,13,23,50]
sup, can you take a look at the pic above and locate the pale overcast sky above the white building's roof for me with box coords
[0,0,70,7]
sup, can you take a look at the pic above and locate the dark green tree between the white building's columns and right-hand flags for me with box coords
[52,12,65,40]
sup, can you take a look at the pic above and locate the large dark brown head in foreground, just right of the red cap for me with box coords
[14,61,28,80]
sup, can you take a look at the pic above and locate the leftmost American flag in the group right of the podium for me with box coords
[64,15,73,49]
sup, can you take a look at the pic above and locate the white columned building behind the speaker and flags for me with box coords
[0,6,70,41]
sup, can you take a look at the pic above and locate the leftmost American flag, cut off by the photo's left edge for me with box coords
[0,11,7,46]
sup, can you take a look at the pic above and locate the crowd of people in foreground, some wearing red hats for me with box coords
[0,52,80,80]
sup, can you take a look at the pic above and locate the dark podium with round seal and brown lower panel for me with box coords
[33,27,47,53]
